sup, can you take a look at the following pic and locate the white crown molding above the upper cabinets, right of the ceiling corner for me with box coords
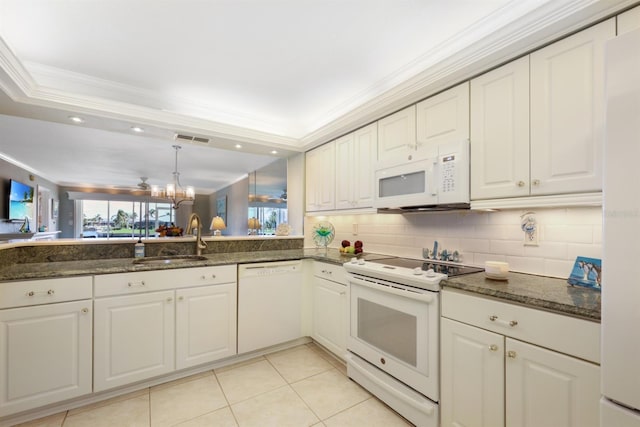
[300,0,637,150]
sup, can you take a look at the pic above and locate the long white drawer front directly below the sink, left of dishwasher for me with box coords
[94,264,237,297]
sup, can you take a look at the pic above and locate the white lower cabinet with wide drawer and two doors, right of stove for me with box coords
[440,291,600,427]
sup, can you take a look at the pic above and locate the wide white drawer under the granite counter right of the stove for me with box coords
[442,289,600,364]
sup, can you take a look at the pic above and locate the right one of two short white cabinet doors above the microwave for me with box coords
[416,82,469,155]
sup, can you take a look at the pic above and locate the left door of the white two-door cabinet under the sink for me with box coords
[94,291,175,391]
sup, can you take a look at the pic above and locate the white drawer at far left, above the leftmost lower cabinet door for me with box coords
[0,276,92,308]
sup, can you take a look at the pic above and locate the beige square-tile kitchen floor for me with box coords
[20,343,411,427]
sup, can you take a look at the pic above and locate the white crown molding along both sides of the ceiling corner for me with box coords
[0,0,637,152]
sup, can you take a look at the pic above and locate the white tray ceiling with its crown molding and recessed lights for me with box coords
[0,0,630,193]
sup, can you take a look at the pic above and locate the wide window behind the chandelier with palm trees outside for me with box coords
[77,200,175,239]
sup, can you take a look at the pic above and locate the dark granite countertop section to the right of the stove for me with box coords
[442,273,601,322]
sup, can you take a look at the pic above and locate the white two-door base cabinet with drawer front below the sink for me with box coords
[94,264,236,392]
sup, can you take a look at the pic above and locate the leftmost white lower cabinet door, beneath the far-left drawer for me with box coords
[0,300,92,417]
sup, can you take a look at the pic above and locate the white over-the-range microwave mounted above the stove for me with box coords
[373,139,470,212]
